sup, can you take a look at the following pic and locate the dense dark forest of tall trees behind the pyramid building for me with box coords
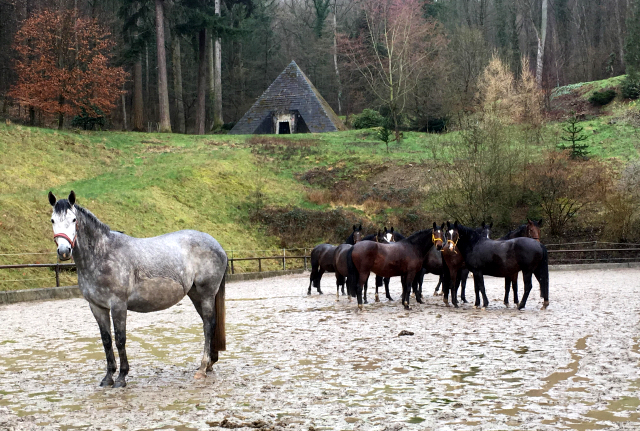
[0,0,640,133]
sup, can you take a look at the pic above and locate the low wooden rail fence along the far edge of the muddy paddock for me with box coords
[0,245,640,286]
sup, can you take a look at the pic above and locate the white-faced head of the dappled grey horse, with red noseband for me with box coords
[49,191,78,260]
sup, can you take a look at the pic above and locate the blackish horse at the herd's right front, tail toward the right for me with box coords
[446,222,549,310]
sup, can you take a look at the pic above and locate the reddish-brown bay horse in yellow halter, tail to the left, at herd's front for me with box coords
[347,223,442,309]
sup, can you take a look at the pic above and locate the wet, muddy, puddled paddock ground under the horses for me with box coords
[0,269,640,431]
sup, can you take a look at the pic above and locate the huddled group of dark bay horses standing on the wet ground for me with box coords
[307,219,549,309]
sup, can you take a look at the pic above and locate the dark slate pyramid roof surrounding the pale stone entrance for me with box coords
[229,61,346,135]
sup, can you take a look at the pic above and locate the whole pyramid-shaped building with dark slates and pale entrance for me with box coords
[229,61,346,135]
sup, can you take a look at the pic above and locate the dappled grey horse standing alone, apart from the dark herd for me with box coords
[49,191,227,388]
